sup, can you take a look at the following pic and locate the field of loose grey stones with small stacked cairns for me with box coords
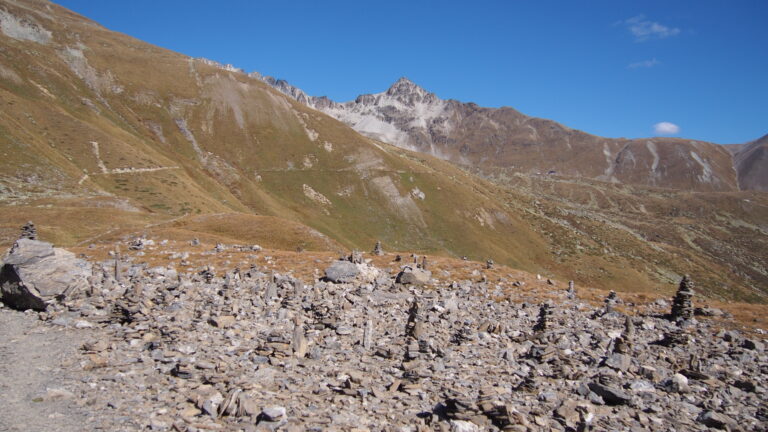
[0,235,768,431]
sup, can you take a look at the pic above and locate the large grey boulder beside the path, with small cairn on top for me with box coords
[0,238,91,311]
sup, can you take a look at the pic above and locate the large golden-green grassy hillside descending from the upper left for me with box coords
[0,1,547,274]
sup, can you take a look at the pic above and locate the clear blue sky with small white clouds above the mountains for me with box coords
[59,0,768,144]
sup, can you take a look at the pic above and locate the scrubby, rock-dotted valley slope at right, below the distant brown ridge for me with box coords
[480,171,768,301]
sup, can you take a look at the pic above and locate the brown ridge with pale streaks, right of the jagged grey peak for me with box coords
[444,101,737,191]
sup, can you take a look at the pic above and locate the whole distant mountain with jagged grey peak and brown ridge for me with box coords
[264,77,738,191]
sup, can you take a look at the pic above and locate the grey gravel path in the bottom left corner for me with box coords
[0,307,101,432]
